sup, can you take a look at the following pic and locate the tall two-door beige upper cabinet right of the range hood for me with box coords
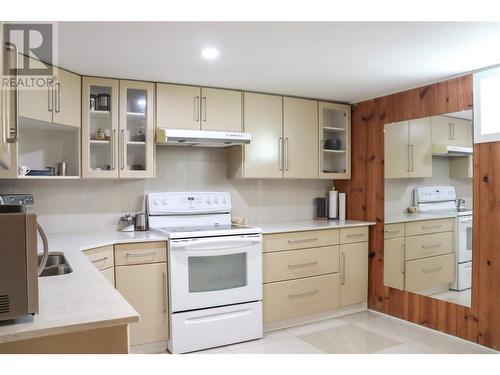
[228,92,319,179]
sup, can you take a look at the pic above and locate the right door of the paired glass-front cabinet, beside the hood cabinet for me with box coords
[119,81,154,178]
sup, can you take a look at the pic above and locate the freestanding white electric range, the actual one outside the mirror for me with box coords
[146,192,263,353]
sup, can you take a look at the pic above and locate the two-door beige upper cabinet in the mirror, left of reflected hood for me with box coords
[384,118,432,178]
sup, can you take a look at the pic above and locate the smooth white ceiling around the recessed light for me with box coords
[59,22,500,102]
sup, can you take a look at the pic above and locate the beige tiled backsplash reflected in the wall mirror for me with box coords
[385,157,472,214]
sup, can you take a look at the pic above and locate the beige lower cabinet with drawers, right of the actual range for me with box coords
[263,227,368,324]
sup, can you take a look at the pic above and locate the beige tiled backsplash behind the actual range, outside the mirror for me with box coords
[0,146,331,233]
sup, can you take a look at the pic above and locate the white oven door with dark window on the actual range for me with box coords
[169,234,262,312]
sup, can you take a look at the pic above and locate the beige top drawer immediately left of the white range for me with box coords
[115,241,167,266]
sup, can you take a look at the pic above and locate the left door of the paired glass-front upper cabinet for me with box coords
[82,77,119,178]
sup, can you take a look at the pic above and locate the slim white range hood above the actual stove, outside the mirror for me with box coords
[156,128,252,147]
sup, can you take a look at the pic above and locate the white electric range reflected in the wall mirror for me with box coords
[413,186,472,290]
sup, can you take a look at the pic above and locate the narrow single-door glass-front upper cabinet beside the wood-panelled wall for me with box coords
[319,102,351,180]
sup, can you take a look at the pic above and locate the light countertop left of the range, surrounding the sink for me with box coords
[0,232,166,343]
